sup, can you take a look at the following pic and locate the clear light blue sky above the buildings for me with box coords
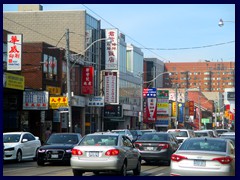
[3,4,235,62]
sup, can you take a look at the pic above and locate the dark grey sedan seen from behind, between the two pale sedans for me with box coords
[134,132,178,165]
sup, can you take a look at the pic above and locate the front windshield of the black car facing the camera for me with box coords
[46,134,78,144]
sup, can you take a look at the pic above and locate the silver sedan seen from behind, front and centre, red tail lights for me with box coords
[71,133,141,176]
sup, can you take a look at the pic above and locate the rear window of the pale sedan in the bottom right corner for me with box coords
[179,139,226,152]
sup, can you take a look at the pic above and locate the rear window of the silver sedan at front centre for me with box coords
[79,135,117,146]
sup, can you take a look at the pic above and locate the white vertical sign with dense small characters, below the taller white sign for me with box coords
[104,71,118,103]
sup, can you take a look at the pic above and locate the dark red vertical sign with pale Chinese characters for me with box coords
[81,66,94,94]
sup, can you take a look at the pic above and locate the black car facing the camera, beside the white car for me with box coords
[37,133,82,166]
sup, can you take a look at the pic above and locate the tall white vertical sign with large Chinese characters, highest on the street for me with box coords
[105,29,118,70]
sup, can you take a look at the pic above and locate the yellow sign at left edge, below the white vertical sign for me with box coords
[3,73,25,90]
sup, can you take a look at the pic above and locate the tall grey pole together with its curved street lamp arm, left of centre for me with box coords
[66,29,111,132]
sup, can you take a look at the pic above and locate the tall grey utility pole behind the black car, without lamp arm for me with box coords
[65,29,72,132]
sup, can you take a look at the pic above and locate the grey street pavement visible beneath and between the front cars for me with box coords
[3,160,170,176]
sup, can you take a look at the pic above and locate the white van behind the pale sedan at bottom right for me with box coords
[167,129,195,144]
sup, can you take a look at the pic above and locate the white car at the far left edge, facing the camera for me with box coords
[3,132,41,162]
